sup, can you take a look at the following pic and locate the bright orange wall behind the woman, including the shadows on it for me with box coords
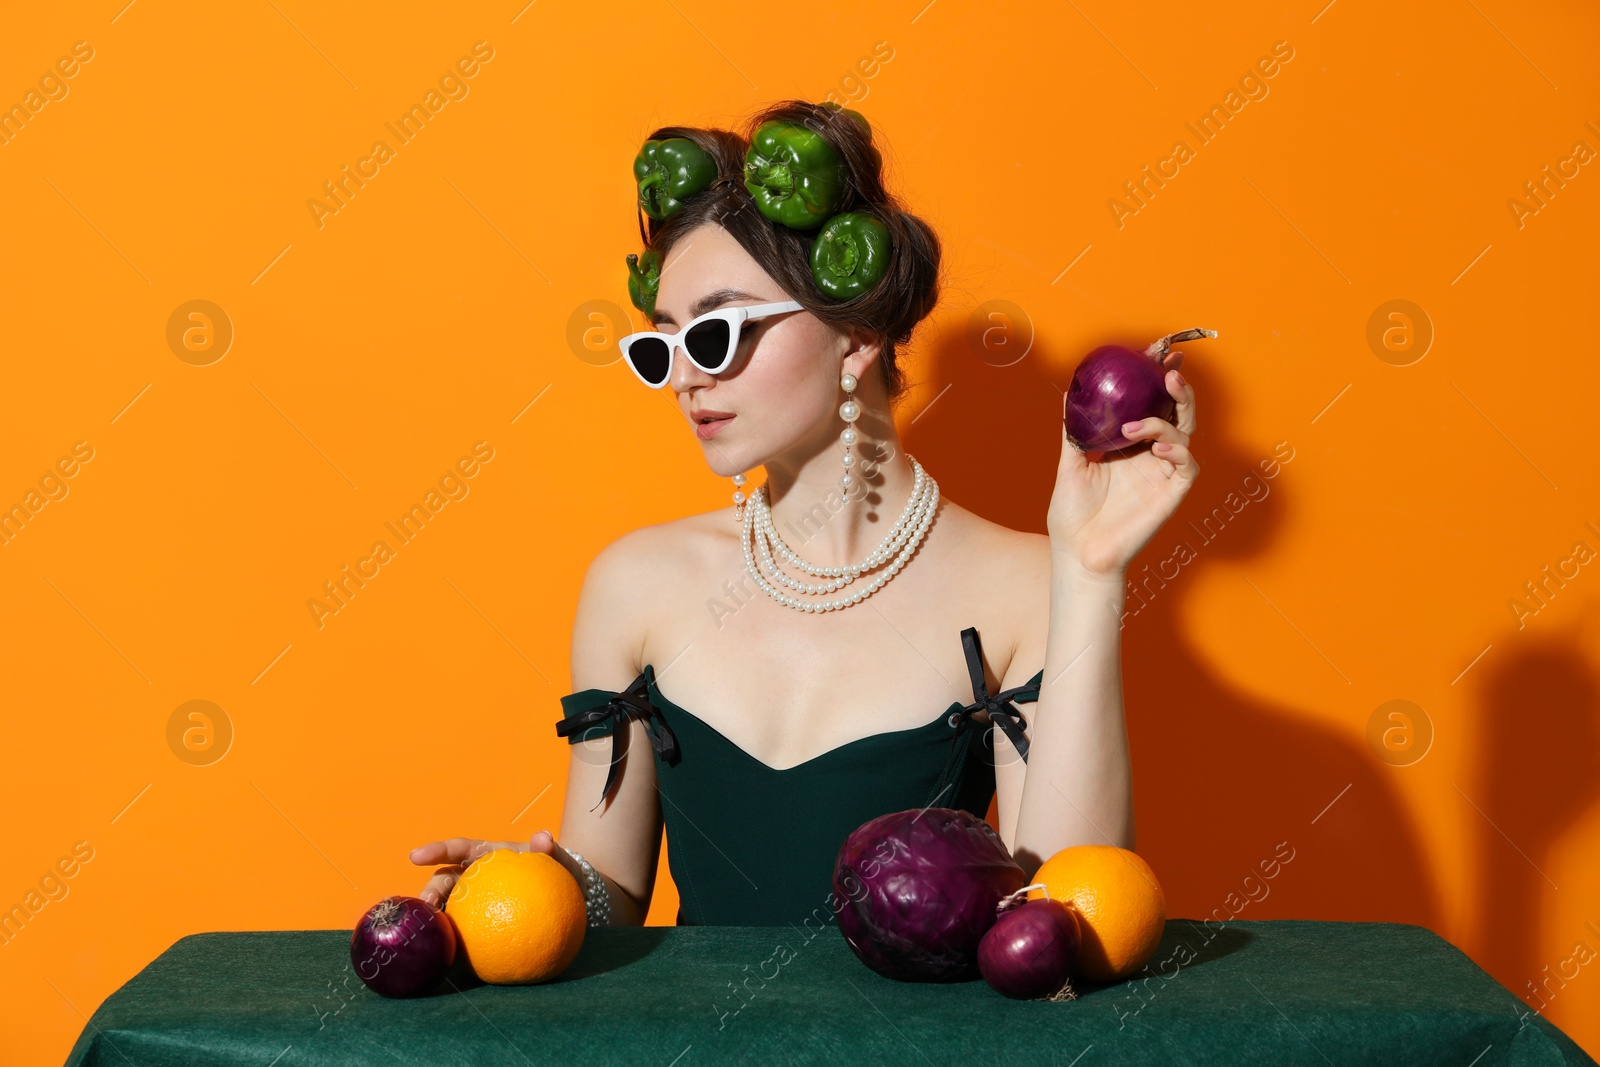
[0,0,1600,1062]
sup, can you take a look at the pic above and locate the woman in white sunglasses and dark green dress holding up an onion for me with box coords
[411,101,1198,925]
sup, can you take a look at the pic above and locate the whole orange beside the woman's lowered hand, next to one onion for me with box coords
[445,848,589,985]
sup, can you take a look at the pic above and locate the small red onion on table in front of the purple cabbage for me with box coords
[978,886,1082,1000]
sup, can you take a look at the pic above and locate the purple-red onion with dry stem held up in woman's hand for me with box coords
[1062,330,1216,453]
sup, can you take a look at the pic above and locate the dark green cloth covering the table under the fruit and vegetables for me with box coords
[67,918,1595,1067]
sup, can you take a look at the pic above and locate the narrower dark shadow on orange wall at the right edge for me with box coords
[1456,630,1600,1014]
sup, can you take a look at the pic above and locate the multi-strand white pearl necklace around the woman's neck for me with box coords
[741,456,939,613]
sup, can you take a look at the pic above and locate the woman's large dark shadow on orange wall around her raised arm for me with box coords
[904,321,1446,937]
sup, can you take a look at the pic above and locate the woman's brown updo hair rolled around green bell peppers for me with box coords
[640,101,939,403]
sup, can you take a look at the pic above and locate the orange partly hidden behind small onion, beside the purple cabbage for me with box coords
[1027,845,1166,982]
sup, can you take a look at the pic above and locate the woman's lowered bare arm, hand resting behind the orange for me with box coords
[411,528,661,926]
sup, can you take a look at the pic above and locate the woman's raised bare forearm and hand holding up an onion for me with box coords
[997,352,1200,877]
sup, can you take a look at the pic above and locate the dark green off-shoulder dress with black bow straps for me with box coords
[555,627,1045,926]
